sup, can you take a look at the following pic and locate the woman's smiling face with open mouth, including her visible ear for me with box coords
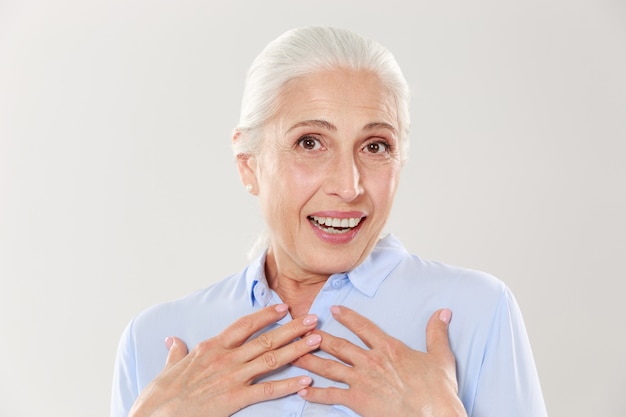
[239,70,401,281]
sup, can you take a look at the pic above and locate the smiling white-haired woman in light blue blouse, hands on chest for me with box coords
[112,27,546,417]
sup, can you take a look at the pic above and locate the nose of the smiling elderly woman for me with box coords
[325,155,363,202]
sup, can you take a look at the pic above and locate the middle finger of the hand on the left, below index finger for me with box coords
[237,314,319,362]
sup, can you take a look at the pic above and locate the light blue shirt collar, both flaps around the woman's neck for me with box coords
[245,234,407,306]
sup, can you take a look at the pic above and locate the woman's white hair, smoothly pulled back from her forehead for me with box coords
[233,27,410,161]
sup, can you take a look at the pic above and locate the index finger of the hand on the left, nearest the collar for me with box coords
[217,304,289,348]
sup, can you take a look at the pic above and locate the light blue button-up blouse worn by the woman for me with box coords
[111,235,547,417]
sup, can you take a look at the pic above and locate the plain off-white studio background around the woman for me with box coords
[0,0,626,417]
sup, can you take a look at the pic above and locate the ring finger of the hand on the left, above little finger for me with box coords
[243,333,322,380]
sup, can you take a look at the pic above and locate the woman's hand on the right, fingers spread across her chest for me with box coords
[293,306,467,417]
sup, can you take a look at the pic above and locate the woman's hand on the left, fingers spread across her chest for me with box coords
[129,304,321,417]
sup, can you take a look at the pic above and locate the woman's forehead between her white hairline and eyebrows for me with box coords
[273,69,398,129]
